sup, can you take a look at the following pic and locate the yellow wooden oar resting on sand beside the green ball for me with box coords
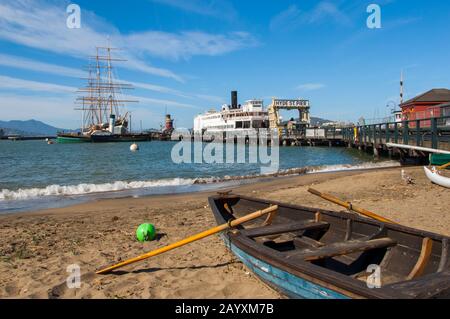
[96,206,278,274]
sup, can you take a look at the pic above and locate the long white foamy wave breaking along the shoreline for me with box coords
[0,161,400,201]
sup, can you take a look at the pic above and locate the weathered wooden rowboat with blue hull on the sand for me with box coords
[209,194,450,299]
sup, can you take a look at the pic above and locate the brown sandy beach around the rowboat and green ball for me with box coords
[0,167,450,298]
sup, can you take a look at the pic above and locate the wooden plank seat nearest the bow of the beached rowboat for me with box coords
[241,221,330,238]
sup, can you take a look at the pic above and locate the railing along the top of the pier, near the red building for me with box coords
[343,116,450,150]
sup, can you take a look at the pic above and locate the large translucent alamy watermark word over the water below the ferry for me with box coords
[171,129,280,174]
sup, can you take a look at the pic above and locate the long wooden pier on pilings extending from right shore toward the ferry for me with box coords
[195,116,450,162]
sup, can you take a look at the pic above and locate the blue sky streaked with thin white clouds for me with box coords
[0,0,450,128]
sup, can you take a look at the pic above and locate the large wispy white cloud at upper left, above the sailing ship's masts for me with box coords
[0,0,256,81]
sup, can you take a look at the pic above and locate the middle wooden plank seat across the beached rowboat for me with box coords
[286,237,397,261]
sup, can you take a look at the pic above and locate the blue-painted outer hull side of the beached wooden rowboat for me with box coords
[227,237,349,299]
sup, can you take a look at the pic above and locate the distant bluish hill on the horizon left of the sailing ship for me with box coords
[0,120,68,136]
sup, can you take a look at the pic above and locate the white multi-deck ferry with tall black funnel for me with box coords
[194,91,269,134]
